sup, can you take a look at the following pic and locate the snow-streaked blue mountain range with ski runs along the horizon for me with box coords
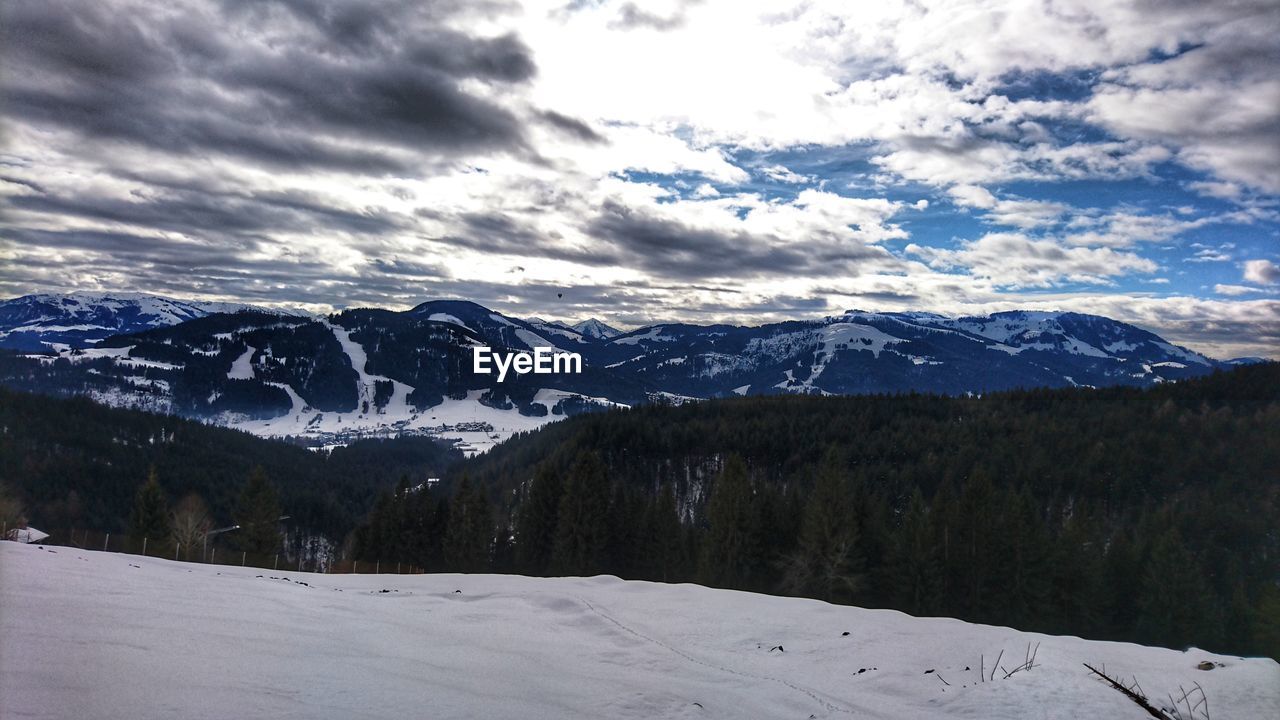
[0,293,1254,450]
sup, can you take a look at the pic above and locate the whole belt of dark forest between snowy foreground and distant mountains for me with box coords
[0,364,1280,657]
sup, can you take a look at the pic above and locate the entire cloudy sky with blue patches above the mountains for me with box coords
[0,0,1280,356]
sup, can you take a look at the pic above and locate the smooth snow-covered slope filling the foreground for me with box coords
[0,542,1280,720]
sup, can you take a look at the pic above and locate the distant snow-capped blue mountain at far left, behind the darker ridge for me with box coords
[0,292,303,350]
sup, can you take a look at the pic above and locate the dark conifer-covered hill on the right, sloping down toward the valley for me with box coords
[353,364,1280,657]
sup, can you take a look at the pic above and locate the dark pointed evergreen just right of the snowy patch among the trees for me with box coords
[700,455,760,589]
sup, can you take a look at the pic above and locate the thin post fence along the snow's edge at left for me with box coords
[0,520,425,575]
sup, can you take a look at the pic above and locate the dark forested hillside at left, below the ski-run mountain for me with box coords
[0,388,460,542]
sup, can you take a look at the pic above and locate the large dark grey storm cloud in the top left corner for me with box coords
[3,0,535,173]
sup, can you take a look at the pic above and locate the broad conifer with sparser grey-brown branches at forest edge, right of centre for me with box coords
[783,448,864,602]
